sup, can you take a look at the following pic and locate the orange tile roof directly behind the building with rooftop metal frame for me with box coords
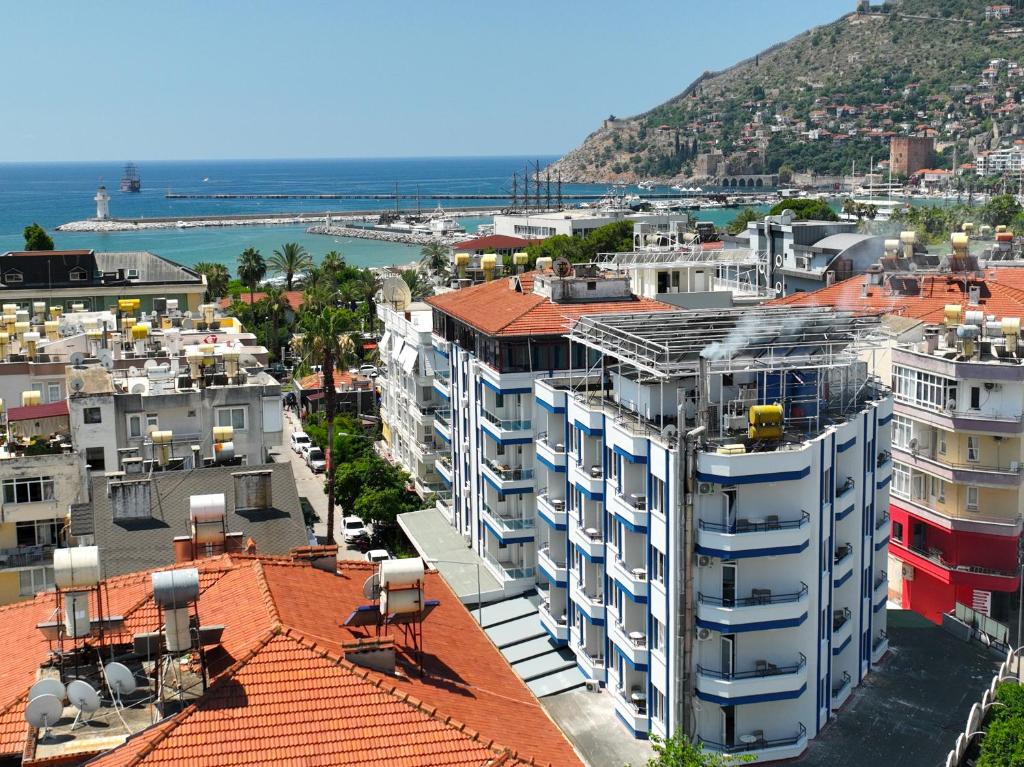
[425,271,673,336]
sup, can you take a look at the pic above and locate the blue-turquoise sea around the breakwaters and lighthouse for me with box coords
[0,156,757,271]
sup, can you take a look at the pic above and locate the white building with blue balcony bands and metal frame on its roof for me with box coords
[532,307,892,762]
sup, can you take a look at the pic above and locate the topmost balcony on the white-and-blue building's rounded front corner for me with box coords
[697,511,811,559]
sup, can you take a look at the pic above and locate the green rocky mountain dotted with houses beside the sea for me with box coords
[551,0,1024,182]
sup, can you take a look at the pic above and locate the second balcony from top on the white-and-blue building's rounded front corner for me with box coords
[697,583,808,634]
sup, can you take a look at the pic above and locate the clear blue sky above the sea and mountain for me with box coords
[0,0,855,162]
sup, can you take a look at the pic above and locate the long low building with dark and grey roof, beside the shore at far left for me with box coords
[0,249,206,311]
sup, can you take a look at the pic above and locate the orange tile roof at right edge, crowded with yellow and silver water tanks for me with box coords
[769,266,1024,323]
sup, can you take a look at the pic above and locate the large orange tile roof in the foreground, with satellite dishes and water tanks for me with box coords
[0,555,582,767]
